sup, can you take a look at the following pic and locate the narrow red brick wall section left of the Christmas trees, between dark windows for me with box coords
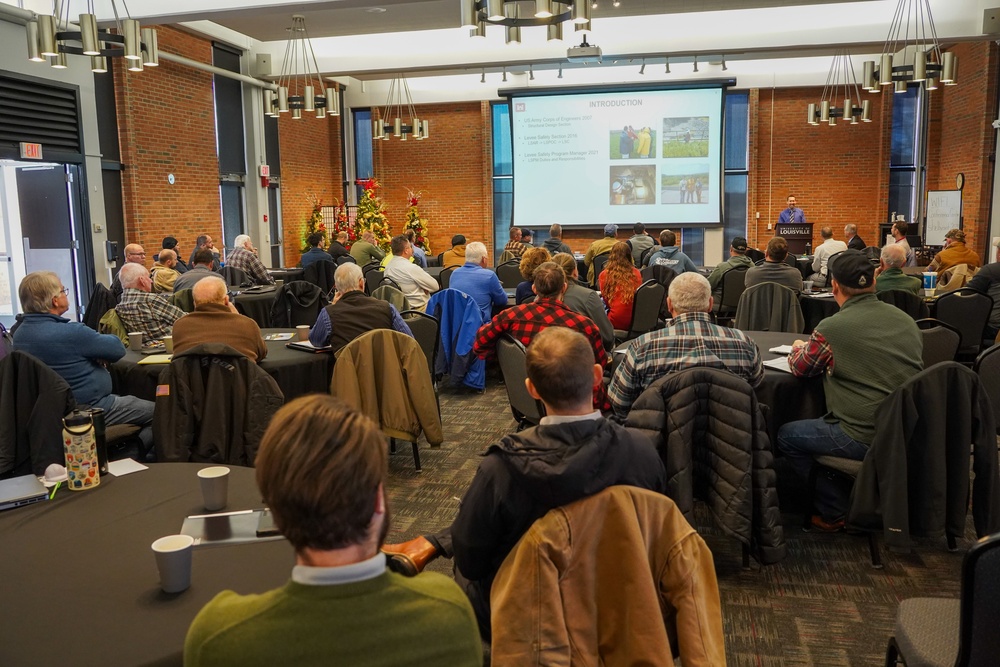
[278,104,344,266]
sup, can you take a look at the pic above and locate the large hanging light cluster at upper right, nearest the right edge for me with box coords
[862,0,958,93]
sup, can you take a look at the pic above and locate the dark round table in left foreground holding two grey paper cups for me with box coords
[0,463,295,667]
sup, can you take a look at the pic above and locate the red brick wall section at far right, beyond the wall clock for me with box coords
[927,41,998,261]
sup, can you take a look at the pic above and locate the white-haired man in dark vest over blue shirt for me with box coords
[309,263,413,352]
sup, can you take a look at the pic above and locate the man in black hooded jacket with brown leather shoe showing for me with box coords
[383,326,666,638]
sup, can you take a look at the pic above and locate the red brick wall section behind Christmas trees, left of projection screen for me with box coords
[372,102,493,257]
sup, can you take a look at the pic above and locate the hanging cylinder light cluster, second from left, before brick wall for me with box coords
[264,14,340,119]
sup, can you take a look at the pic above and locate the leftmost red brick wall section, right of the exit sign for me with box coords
[114,26,222,265]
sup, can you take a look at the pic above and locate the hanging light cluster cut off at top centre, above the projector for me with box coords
[461,0,591,44]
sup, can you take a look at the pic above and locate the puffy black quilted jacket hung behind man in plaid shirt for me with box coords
[626,367,787,564]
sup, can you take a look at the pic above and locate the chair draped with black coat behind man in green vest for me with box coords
[803,361,1000,568]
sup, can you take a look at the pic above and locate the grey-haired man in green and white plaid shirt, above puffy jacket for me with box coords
[608,272,764,419]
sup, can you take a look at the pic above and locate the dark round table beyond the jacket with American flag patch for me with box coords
[108,329,334,402]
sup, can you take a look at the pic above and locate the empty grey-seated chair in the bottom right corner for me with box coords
[885,535,1000,667]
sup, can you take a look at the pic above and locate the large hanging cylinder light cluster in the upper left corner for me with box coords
[26,0,160,72]
